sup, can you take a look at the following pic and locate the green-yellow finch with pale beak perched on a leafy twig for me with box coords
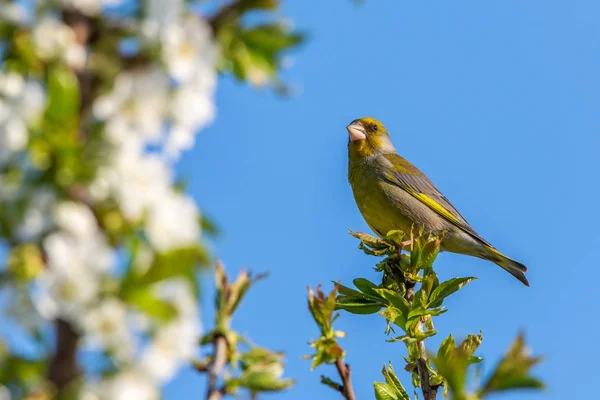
[346,117,529,286]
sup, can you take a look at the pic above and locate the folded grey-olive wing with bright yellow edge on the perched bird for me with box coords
[383,154,491,247]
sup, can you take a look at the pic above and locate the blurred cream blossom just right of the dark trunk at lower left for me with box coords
[81,298,135,362]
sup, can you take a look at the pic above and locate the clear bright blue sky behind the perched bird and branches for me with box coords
[165,0,600,400]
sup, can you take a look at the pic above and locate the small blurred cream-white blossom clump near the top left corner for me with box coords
[33,16,86,69]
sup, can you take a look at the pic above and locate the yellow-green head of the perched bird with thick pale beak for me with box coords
[346,117,396,157]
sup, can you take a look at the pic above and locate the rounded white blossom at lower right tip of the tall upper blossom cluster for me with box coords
[146,191,200,252]
